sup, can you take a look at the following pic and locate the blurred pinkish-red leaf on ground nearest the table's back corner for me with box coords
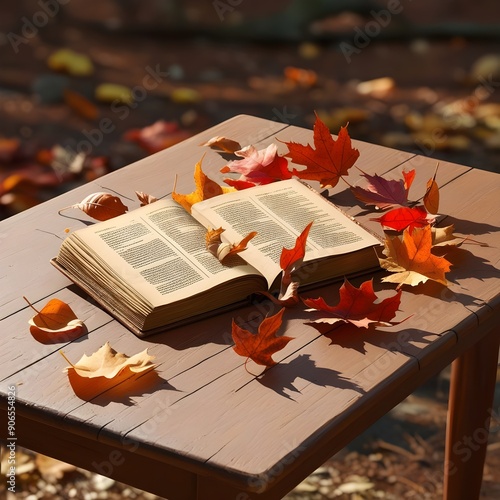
[124,120,191,154]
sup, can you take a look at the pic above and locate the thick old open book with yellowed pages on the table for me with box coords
[52,179,380,336]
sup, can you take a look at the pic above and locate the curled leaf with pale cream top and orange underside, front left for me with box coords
[61,342,157,400]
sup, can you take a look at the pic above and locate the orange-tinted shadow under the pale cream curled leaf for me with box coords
[68,370,177,407]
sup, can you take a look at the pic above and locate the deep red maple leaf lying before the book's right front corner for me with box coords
[303,279,402,328]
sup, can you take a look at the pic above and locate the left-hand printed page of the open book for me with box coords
[63,200,264,306]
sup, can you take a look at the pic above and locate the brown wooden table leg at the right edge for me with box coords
[443,330,500,500]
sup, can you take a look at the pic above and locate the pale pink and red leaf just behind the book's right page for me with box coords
[221,144,292,189]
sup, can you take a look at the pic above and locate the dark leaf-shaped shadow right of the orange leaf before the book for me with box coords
[256,354,365,401]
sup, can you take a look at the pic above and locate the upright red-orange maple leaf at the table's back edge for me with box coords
[285,115,359,187]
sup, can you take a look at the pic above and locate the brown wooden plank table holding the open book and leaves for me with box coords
[0,116,500,500]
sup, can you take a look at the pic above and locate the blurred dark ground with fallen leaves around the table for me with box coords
[0,0,500,500]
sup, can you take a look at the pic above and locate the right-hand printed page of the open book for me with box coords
[192,179,380,290]
